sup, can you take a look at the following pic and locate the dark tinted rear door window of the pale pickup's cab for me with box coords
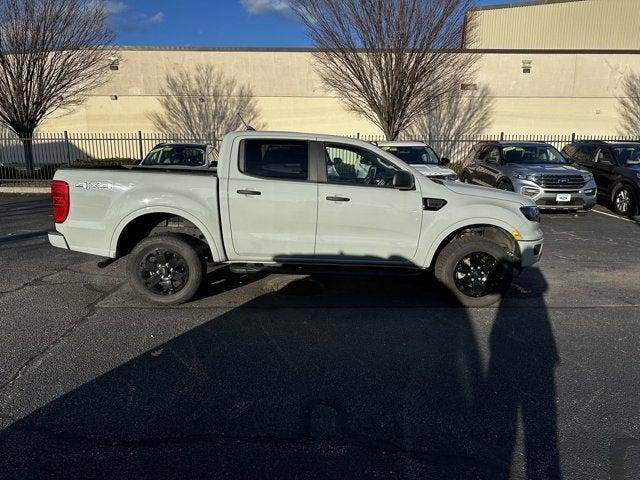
[240,139,309,180]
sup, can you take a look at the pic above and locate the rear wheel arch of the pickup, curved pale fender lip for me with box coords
[109,207,222,262]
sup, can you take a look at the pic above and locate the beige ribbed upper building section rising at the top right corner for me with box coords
[467,0,640,50]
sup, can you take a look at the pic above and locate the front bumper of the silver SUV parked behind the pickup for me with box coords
[512,179,598,210]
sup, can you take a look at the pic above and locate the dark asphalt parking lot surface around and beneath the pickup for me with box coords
[0,195,640,479]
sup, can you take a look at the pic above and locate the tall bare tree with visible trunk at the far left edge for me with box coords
[0,0,114,175]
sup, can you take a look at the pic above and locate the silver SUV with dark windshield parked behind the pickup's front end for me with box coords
[460,142,597,210]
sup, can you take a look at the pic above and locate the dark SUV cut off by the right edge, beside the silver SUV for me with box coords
[562,141,640,216]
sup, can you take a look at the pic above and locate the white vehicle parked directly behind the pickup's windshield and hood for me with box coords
[376,142,458,181]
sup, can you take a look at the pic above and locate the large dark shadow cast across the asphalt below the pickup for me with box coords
[0,269,560,479]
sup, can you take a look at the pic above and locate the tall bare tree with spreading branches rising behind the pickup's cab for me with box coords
[292,0,477,140]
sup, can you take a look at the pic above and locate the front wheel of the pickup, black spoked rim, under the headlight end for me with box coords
[434,235,514,307]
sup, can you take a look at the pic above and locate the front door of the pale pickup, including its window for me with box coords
[316,144,422,264]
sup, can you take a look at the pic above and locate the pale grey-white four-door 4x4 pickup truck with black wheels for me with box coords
[49,131,543,306]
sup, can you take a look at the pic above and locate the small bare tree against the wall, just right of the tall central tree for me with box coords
[407,85,494,161]
